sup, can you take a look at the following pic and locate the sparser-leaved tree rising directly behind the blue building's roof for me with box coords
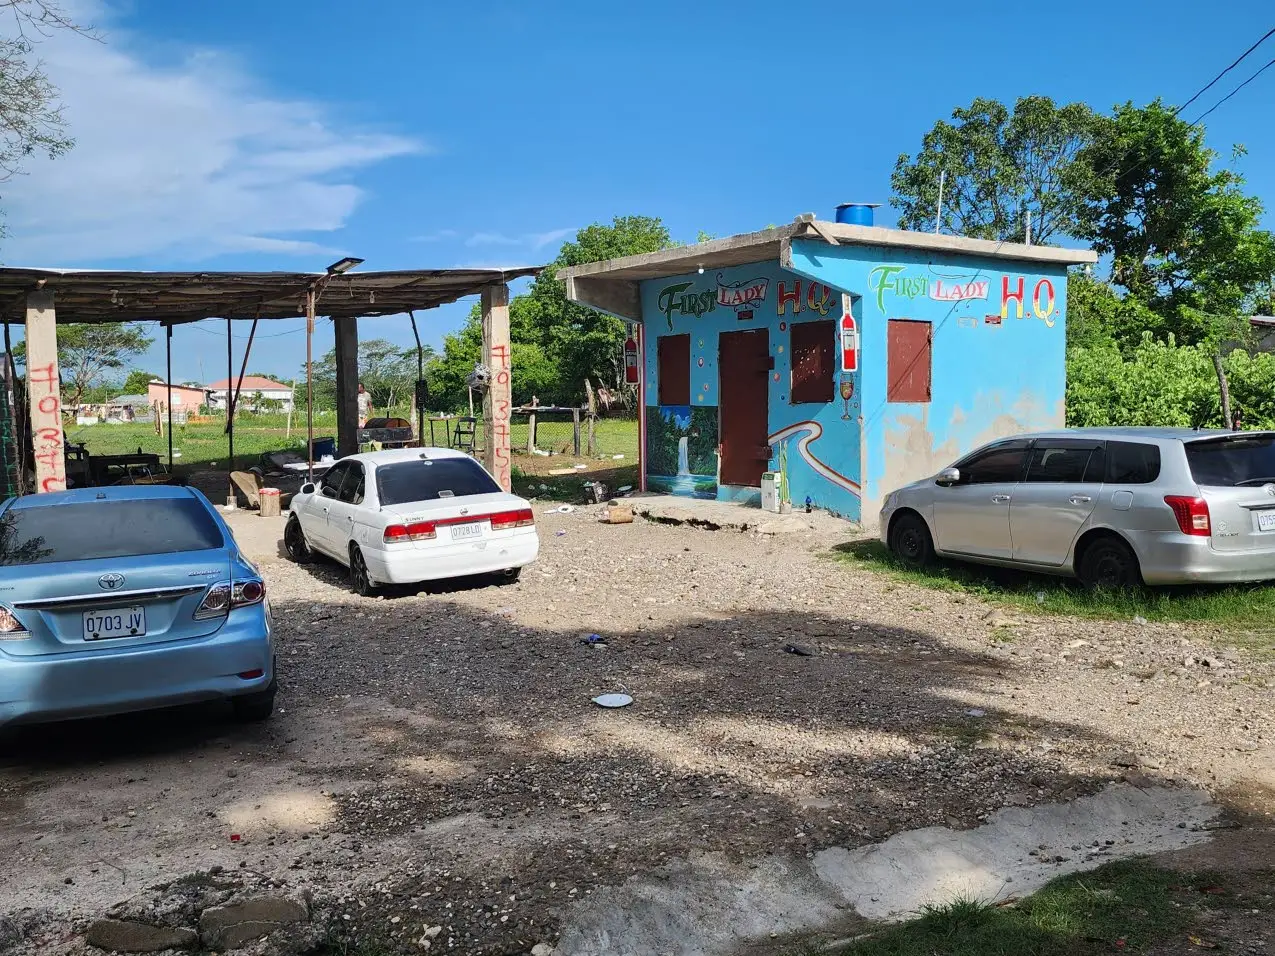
[890,96,1094,242]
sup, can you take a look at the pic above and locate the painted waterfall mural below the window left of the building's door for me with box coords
[646,405,718,498]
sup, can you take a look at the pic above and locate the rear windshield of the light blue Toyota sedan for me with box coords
[0,498,226,566]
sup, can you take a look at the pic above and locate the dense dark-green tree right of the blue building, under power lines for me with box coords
[1063,101,1275,343]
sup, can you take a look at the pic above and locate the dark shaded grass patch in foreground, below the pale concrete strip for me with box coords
[824,860,1253,956]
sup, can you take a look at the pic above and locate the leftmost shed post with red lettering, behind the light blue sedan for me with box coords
[27,289,66,493]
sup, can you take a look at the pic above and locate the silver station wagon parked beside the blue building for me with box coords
[881,428,1275,588]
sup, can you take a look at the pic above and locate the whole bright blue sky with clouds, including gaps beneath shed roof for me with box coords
[0,0,1275,380]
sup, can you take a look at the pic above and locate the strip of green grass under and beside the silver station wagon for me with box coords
[834,540,1275,651]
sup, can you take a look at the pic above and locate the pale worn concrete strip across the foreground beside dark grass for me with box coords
[556,784,1218,956]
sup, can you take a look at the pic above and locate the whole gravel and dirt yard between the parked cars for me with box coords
[0,503,1275,953]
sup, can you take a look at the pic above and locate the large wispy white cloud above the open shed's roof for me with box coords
[0,0,428,265]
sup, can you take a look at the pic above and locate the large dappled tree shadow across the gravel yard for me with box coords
[0,599,1188,955]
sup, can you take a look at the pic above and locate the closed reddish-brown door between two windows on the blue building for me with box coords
[718,329,770,488]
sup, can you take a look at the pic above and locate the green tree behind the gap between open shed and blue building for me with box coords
[430,215,674,408]
